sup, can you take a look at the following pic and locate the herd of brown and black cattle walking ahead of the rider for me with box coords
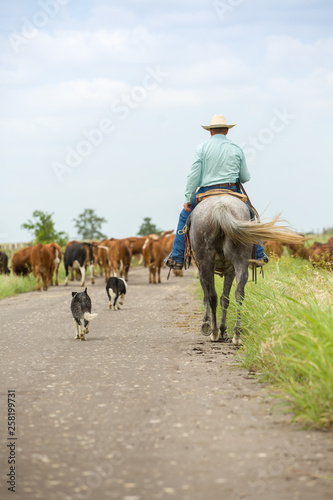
[0,231,333,291]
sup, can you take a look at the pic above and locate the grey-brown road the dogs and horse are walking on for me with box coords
[0,268,333,500]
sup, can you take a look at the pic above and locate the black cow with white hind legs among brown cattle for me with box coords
[64,243,95,286]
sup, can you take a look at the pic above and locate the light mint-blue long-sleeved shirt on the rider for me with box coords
[185,134,251,203]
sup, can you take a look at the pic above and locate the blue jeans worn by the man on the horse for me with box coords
[171,186,264,264]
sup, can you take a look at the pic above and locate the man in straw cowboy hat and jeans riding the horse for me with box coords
[166,115,268,270]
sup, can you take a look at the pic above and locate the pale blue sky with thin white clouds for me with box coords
[0,0,333,243]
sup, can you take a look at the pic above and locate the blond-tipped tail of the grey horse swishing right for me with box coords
[212,203,305,245]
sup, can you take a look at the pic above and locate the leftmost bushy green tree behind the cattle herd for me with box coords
[21,210,68,246]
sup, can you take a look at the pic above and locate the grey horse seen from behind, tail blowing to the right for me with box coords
[187,195,304,345]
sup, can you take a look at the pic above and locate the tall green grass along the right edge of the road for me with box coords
[210,257,333,428]
